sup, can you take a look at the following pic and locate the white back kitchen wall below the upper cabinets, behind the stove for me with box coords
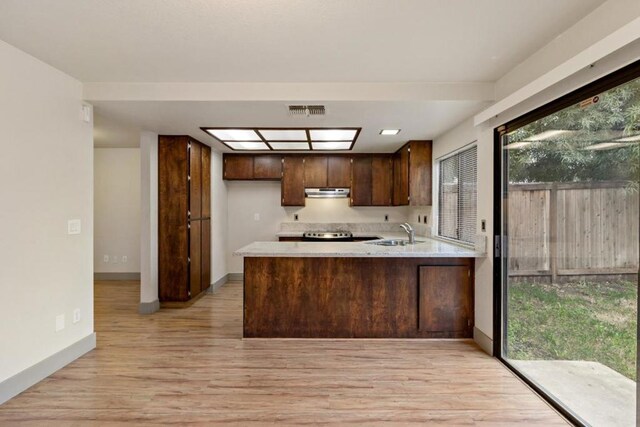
[228,181,409,273]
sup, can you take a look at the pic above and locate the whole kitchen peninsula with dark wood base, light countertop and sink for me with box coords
[234,233,483,338]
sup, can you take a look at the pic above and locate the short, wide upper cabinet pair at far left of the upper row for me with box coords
[223,153,282,181]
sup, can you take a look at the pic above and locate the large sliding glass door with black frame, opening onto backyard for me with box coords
[496,67,640,426]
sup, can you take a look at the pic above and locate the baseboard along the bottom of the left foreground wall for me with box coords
[0,332,96,404]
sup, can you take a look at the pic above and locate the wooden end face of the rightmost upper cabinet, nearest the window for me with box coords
[409,141,433,206]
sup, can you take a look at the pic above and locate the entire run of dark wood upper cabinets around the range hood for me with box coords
[221,145,432,208]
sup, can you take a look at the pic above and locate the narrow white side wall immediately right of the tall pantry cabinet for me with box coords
[211,150,229,283]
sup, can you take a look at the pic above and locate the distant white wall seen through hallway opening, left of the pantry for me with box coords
[93,148,140,273]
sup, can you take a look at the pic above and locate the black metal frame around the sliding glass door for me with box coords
[493,60,640,426]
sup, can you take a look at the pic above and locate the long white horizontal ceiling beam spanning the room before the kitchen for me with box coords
[83,82,495,102]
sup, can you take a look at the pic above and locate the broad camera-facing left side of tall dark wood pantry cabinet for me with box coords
[158,136,189,301]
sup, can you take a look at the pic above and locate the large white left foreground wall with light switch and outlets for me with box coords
[0,41,93,382]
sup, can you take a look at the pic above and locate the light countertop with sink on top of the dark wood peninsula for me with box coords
[233,232,485,258]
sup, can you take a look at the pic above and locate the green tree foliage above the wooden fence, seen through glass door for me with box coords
[508,79,640,189]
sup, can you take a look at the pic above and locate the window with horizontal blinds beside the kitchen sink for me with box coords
[438,146,478,244]
